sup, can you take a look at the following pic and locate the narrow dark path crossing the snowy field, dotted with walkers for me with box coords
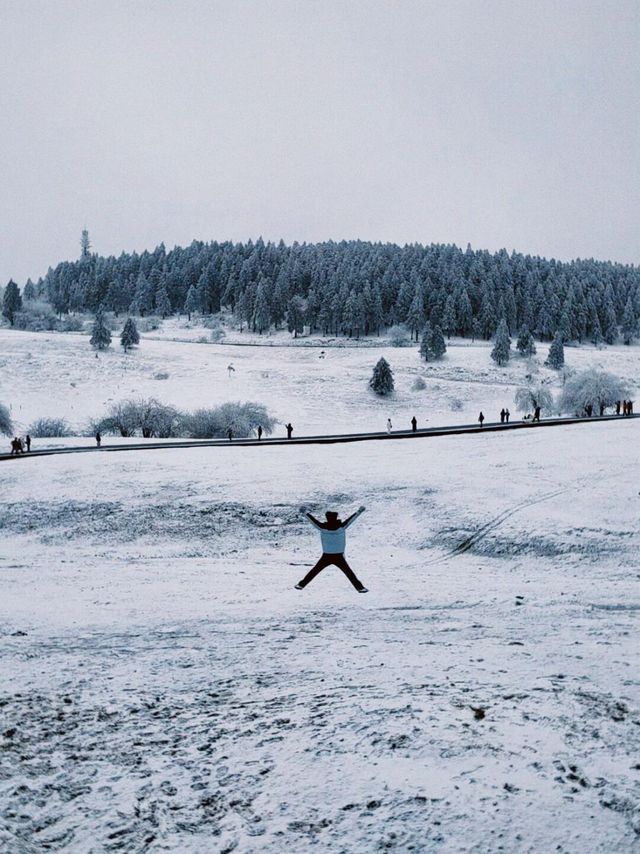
[0,415,639,461]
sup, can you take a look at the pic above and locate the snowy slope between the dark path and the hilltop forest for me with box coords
[0,321,638,436]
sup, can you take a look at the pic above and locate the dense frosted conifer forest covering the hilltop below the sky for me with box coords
[5,234,640,344]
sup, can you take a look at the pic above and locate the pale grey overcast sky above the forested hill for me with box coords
[0,0,640,284]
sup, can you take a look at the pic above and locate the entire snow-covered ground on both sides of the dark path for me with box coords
[0,331,640,854]
